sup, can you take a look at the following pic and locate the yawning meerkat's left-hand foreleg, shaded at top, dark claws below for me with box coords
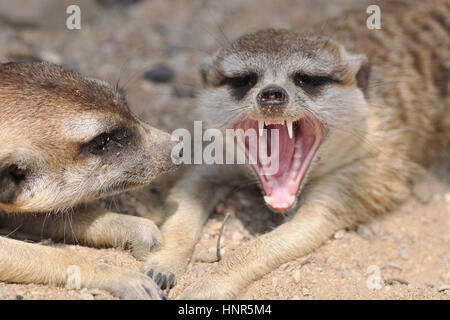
[143,167,231,289]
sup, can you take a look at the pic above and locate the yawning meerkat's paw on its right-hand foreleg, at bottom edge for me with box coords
[177,275,239,300]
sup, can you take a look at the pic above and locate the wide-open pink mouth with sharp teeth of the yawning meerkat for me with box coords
[235,117,323,211]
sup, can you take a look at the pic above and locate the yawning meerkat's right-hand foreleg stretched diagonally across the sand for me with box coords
[179,205,344,299]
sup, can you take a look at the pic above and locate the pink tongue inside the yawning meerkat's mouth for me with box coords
[258,124,295,177]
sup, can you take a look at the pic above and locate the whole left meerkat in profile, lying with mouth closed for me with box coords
[0,62,179,299]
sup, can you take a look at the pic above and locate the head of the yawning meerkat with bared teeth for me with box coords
[199,29,368,211]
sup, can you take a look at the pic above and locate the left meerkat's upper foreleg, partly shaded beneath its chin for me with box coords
[0,204,161,260]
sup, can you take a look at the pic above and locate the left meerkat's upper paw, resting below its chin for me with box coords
[111,215,162,261]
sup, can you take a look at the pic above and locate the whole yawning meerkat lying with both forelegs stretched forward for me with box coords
[145,1,450,299]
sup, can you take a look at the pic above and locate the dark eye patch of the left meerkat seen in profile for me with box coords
[80,128,135,155]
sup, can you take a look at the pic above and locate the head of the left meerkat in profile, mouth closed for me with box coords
[0,63,179,212]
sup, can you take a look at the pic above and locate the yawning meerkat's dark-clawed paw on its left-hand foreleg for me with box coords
[143,251,189,290]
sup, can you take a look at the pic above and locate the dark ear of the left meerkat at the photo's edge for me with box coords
[0,159,29,204]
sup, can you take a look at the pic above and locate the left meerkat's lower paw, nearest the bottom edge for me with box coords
[93,266,168,300]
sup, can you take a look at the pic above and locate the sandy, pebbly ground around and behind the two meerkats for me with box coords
[0,0,450,299]
